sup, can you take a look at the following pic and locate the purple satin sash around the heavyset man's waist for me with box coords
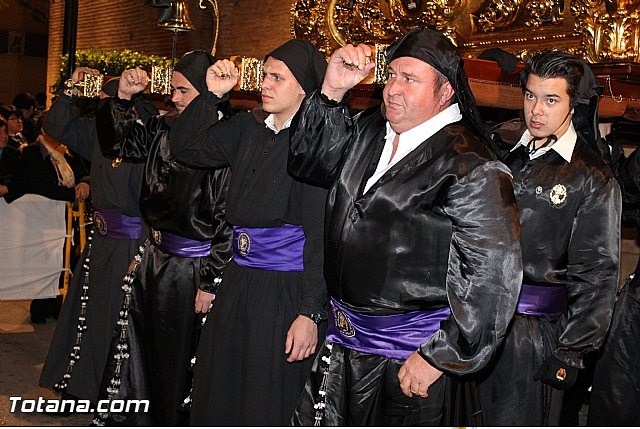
[327,299,451,359]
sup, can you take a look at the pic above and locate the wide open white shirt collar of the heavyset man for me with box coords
[364,103,462,192]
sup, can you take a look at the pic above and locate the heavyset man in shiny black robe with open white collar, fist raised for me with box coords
[289,28,522,426]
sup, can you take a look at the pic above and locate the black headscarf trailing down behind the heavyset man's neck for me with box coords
[386,27,488,140]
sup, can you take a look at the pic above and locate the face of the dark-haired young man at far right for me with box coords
[524,74,573,138]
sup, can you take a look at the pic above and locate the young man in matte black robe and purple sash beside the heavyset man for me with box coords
[172,40,327,426]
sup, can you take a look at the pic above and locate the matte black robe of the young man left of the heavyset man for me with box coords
[171,92,327,426]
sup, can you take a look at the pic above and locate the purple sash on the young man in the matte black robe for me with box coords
[233,224,306,271]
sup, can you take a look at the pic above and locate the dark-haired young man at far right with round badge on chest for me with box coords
[479,51,621,426]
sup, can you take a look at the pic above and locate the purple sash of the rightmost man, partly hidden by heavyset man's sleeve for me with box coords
[516,284,567,319]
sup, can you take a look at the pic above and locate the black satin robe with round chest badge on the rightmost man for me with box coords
[479,129,621,426]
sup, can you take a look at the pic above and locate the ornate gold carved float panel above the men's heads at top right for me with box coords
[291,0,640,62]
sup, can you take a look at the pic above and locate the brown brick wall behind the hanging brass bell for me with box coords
[47,0,292,104]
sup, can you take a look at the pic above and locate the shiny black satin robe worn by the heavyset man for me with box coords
[289,92,522,425]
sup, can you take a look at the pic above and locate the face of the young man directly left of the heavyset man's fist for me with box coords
[262,57,305,119]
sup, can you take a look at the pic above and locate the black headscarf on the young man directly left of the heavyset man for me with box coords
[264,39,327,94]
